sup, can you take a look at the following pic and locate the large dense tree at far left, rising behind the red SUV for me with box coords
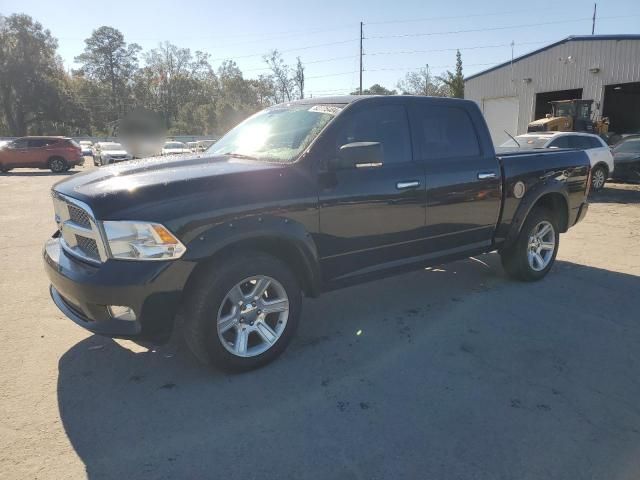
[0,14,86,136]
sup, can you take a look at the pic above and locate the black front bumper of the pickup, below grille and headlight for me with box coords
[43,238,195,339]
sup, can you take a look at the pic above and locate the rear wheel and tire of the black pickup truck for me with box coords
[500,207,560,282]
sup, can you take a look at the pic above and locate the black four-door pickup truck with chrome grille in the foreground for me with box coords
[44,96,590,369]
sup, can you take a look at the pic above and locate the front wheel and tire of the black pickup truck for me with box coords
[183,252,302,371]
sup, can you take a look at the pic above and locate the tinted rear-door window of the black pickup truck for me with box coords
[416,105,480,158]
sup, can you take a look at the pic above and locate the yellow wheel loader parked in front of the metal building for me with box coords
[527,100,609,135]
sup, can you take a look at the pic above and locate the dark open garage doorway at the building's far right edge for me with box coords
[602,82,640,133]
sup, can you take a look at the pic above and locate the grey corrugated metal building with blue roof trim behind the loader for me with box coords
[464,35,640,144]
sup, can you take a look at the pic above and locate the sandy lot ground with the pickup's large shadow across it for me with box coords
[0,163,640,480]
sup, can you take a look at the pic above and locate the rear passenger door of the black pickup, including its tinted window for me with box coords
[411,99,502,254]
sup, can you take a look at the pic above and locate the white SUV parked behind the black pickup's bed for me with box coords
[496,132,614,191]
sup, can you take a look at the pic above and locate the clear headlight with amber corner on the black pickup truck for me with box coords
[103,221,187,260]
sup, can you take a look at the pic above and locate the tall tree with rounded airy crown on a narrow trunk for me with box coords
[75,26,141,121]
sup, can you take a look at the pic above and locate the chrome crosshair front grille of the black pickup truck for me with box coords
[51,191,107,263]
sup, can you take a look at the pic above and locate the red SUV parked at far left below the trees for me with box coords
[0,137,84,173]
